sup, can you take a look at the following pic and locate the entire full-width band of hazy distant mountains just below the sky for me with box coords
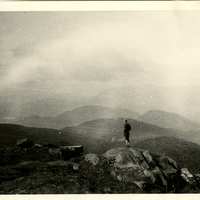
[0,85,200,121]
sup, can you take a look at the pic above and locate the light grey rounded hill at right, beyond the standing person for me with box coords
[137,110,200,131]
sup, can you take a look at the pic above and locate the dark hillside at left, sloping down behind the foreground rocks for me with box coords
[0,124,122,153]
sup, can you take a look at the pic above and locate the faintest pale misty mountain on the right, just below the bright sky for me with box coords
[92,85,200,121]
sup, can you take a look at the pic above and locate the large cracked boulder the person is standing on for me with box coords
[102,147,191,190]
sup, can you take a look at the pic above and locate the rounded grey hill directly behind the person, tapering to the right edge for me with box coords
[62,118,200,143]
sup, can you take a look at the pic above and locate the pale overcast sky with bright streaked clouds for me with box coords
[0,11,200,94]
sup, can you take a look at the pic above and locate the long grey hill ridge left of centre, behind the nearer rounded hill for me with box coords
[6,105,140,129]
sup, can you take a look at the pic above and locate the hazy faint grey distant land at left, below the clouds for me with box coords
[0,88,94,118]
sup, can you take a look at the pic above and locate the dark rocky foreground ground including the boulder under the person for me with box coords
[0,139,200,194]
